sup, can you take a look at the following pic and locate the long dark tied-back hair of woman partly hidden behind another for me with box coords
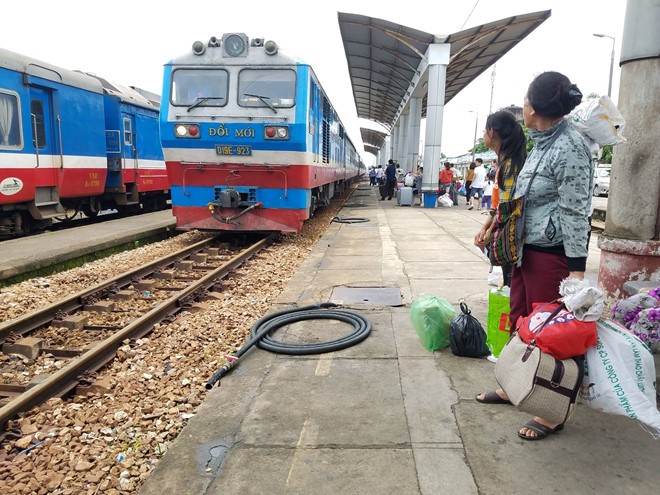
[486,110,527,191]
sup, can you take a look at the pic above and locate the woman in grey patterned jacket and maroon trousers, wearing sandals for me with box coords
[475,72,593,440]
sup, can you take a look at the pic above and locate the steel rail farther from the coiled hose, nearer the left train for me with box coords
[0,237,222,344]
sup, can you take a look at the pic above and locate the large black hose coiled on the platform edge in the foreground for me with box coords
[206,303,371,390]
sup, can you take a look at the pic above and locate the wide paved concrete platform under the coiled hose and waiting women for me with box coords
[133,184,660,495]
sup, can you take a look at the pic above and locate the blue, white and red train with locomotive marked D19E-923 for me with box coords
[160,33,366,233]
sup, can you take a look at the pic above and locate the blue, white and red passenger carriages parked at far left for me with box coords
[0,49,170,237]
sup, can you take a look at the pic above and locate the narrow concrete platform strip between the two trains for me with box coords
[0,210,176,280]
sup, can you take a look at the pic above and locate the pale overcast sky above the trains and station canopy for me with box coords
[0,0,626,164]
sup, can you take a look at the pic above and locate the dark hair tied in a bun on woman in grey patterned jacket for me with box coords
[527,72,582,117]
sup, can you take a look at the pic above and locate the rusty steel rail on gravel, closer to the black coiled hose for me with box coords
[0,235,274,431]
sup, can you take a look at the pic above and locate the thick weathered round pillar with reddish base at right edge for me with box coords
[598,0,660,299]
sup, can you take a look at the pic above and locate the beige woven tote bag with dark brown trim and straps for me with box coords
[495,332,584,423]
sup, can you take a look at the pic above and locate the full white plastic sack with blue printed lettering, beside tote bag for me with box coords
[580,320,660,439]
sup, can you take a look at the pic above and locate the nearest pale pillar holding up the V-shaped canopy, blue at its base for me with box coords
[422,43,451,208]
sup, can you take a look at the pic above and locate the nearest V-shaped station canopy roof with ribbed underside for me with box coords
[338,10,551,134]
